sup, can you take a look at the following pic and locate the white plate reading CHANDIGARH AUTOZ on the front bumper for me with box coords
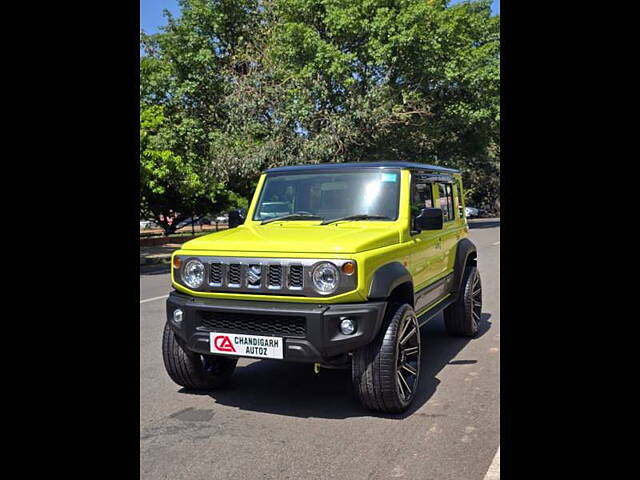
[209,332,284,359]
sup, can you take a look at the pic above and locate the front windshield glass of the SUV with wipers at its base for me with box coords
[253,169,400,221]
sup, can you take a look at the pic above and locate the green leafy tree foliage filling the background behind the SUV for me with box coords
[140,0,500,223]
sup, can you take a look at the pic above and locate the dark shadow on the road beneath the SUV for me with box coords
[179,313,491,419]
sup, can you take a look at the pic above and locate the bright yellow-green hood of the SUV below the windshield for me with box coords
[182,222,400,253]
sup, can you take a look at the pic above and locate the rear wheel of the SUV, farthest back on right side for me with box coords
[444,265,482,337]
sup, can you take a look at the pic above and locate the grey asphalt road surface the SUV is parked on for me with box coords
[140,219,500,480]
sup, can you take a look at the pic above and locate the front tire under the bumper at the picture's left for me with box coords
[162,322,238,390]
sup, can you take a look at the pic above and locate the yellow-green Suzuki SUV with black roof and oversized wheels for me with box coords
[162,162,482,412]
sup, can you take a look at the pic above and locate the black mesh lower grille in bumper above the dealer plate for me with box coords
[199,311,307,337]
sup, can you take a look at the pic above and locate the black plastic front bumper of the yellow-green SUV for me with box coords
[167,291,386,362]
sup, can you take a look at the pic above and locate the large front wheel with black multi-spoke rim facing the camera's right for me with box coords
[351,304,421,413]
